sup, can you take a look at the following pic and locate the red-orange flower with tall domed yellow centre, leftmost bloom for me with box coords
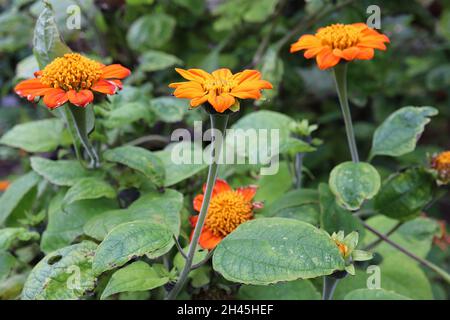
[14,53,131,109]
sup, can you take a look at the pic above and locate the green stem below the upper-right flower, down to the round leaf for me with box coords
[333,63,359,162]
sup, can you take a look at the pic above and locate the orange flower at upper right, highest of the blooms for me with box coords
[291,23,390,70]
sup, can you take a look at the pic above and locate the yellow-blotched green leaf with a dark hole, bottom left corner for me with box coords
[22,241,97,300]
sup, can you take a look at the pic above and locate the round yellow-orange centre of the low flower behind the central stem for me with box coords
[205,191,253,237]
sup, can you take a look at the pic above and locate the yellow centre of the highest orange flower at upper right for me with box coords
[316,23,360,50]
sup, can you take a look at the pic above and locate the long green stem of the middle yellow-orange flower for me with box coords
[167,114,228,300]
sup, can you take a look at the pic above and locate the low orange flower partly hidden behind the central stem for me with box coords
[190,179,261,250]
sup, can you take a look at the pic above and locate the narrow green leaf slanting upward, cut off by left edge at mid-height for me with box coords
[0,172,40,225]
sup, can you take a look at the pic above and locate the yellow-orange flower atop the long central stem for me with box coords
[169,68,272,113]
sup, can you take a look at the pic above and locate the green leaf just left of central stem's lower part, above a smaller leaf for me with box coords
[93,221,174,274]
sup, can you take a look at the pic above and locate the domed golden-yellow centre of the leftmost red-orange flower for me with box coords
[41,53,102,91]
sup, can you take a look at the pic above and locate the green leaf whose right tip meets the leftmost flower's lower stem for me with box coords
[30,157,99,187]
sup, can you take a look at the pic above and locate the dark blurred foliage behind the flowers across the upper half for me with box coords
[0,0,450,298]
